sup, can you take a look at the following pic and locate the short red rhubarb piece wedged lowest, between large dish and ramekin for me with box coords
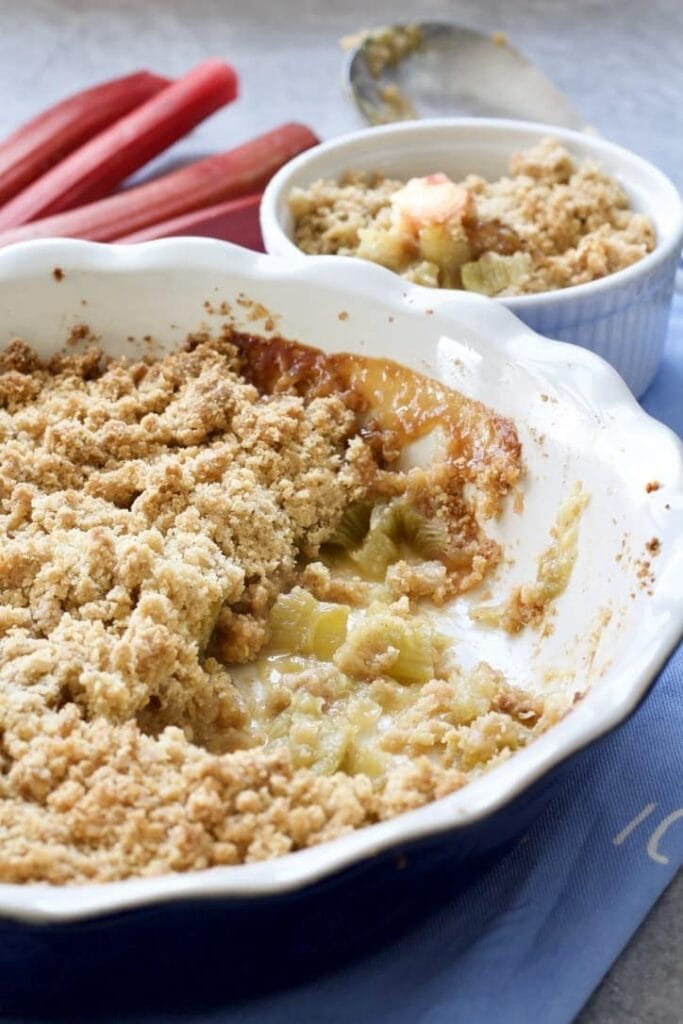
[115,193,263,252]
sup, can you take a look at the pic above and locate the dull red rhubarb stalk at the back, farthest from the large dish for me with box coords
[0,71,170,204]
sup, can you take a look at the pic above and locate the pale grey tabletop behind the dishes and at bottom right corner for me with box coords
[0,0,683,1024]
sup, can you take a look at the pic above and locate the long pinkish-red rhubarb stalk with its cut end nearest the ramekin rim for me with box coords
[0,124,317,245]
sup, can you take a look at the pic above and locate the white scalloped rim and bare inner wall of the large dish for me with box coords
[0,239,683,920]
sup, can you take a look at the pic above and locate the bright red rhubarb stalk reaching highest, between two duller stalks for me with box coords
[0,60,238,230]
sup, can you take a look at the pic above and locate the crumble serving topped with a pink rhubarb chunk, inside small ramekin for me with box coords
[289,138,655,296]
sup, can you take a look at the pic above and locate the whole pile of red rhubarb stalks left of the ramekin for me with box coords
[0,59,317,248]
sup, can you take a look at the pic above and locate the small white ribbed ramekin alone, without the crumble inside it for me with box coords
[261,118,683,395]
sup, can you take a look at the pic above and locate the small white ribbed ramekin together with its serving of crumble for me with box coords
[261,119,683,395]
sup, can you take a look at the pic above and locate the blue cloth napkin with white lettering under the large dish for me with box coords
[5,296,683,1024]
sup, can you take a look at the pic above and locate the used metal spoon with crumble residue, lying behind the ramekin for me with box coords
[345,22,592,131]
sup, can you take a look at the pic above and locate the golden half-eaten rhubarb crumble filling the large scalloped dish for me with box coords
[0,331,565,884]
